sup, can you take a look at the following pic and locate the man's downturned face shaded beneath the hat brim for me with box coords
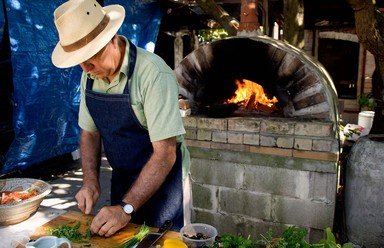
[80,40,117,78]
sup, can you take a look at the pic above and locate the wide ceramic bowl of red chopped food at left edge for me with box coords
[0,178,52,225]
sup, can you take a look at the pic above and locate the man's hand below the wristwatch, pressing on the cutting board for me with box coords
[90,206,131,237]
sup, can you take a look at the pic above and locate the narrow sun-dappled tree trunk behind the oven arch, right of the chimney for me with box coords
[283,0,304,49]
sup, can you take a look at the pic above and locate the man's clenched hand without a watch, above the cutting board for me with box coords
[75,183,101,214]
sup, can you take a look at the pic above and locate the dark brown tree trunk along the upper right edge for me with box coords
[345,0,384,134]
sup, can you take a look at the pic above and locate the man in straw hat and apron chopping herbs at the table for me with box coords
[52,0,190,237]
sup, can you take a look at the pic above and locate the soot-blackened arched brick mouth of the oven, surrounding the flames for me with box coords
[174,36,338,123]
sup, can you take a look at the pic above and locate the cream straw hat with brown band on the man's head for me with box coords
[52,0,125,68]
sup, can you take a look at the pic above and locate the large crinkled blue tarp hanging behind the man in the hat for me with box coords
[0,0,162,174]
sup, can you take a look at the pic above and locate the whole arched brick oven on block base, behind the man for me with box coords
[175,36,340,242]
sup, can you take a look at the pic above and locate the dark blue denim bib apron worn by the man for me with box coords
[85,42,183,231]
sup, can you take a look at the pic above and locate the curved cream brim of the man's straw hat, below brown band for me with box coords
[51,5,125,68]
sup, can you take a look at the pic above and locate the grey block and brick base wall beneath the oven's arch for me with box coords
[184,116,339,242]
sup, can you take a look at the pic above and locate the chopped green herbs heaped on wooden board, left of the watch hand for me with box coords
[46,221,91,243]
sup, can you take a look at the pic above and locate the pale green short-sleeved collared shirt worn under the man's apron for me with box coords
[79,36,189,178]
